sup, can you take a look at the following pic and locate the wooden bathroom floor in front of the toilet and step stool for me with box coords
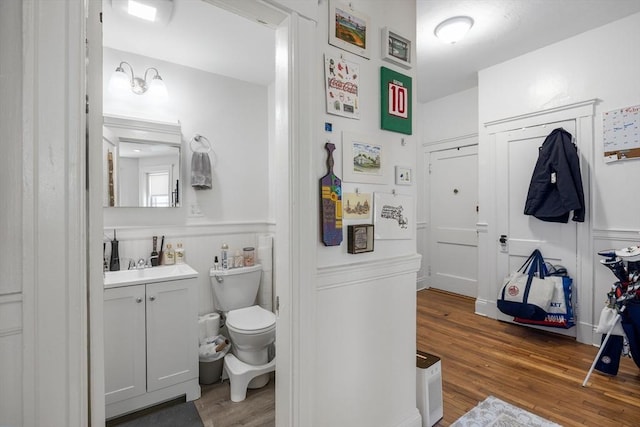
[195,373,276,427]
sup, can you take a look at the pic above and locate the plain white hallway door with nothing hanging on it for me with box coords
[428,145,478,298]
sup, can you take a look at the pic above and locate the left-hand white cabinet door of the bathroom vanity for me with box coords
[104,285,146,404]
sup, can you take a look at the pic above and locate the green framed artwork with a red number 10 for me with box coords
[380,67,412,135]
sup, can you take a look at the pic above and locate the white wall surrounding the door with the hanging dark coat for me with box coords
[479,14,640,342]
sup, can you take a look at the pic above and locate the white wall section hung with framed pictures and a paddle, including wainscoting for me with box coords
[310,0,420,426]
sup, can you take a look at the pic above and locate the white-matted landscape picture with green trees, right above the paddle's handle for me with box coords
[342,131,386,184]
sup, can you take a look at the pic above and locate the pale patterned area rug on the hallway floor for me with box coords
[451,396,562,427]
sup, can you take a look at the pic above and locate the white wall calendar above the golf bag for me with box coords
[602,105,640,163]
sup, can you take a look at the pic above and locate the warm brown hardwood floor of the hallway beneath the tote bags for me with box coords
[417,289,640,427]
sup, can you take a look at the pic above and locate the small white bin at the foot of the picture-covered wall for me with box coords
[416,350,444,427]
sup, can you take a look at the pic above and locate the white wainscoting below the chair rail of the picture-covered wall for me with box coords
[314,254,420,426]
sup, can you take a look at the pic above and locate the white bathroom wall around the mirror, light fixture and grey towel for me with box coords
[103,48,273,314]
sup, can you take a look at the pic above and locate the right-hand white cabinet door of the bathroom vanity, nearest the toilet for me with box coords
[147,279,198,391]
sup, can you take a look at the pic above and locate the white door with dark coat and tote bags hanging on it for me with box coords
[496,120,577,336]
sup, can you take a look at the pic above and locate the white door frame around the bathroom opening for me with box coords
[82,0,317,427]
